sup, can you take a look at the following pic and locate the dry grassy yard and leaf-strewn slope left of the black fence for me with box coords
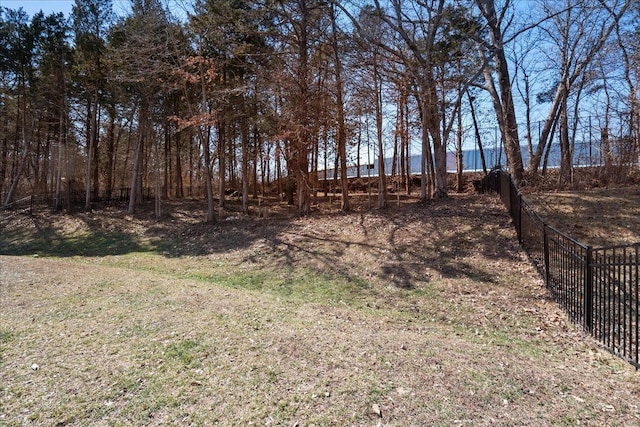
[0,196,640,426]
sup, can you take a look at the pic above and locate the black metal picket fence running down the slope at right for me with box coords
[489,170,640,369]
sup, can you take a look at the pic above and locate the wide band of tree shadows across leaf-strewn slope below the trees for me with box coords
[0,196,518,296]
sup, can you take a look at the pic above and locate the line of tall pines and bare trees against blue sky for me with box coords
[0,0,640,221]
